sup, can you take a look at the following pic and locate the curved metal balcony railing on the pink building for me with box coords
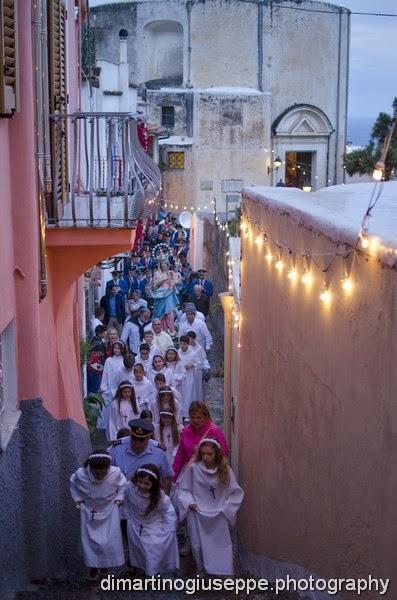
[45,112,161,230]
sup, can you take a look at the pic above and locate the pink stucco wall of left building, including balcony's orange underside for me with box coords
[0,0,133,426]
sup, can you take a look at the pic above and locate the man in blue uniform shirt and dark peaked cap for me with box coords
[109,419,172,494]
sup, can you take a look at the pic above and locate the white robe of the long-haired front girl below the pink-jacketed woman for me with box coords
[178,462,244,575]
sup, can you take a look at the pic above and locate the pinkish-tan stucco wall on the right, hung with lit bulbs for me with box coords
[238,198,397,597]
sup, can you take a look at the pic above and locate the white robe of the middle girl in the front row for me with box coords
[124,483,179,575]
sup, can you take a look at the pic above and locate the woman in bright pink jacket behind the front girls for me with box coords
[172,400,229,482]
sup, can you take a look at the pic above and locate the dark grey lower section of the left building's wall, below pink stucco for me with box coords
[0,400,91,600]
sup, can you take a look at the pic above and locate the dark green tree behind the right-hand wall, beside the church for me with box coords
[345,97,397,181]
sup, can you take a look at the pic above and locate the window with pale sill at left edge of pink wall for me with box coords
[0,321,21,452]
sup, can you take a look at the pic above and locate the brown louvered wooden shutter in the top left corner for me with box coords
[0,0,18,117]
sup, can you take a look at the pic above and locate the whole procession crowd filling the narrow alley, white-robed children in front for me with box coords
[71,214,243,579]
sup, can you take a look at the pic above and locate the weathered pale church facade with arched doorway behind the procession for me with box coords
[90,0,350,212]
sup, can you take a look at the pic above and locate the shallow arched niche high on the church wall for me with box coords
[144,21,183,85]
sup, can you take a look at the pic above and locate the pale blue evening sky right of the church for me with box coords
[318,0,397,119]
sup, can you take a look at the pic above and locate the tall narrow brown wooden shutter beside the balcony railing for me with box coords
[48,0,69,209]
